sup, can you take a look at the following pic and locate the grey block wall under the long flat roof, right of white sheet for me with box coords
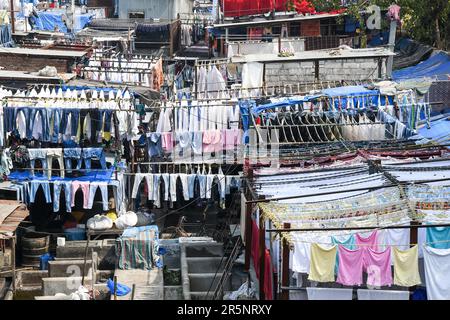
[265,59,386,86]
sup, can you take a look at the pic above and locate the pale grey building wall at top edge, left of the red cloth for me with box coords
[119,0,193,19]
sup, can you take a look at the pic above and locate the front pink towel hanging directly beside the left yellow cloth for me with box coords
[336,246,365,286]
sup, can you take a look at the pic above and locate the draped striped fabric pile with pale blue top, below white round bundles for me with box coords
[116,226,162,270]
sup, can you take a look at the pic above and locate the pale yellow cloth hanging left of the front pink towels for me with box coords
[308,243,337,282]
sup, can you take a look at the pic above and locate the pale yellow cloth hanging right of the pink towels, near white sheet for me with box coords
[392,245,421,287]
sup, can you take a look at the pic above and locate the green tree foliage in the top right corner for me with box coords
[311,0,450,50]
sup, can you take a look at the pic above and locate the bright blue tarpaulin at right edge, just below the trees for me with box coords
[392,52,450,81]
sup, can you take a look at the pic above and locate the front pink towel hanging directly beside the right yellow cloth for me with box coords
[363,247,392,287]
